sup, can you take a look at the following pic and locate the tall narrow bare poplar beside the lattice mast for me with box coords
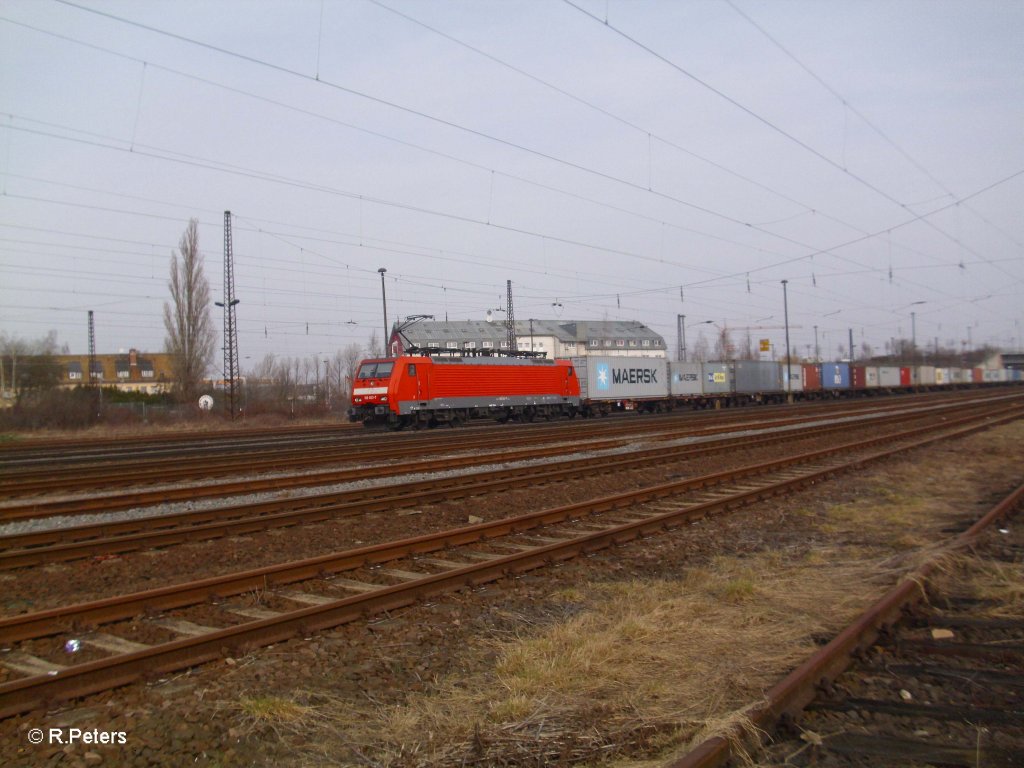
[164,219,216,402]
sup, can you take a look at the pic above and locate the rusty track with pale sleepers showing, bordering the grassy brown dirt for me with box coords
[0,397,1018,716]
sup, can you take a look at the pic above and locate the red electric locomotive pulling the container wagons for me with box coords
[348,356,580,429]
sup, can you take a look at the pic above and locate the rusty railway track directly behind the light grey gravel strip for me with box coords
[6,393,1024,522]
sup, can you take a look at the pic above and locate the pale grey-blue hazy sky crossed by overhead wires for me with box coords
[0,0,1024,372]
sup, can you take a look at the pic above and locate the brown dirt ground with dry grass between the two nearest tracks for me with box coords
[0,423,1024,767]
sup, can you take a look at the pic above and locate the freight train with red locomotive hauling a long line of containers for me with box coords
[349,354,1022,429]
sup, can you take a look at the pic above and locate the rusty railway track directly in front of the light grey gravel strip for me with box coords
[0,406,1011,570]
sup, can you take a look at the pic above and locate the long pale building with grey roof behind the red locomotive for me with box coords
[388,319,667,358]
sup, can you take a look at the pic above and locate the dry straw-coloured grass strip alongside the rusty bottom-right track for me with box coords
[258,425,1024,768]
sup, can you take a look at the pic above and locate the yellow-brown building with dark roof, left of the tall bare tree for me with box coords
[53,349,174,394]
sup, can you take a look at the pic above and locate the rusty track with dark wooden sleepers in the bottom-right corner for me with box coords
[670,468,1024,768]
